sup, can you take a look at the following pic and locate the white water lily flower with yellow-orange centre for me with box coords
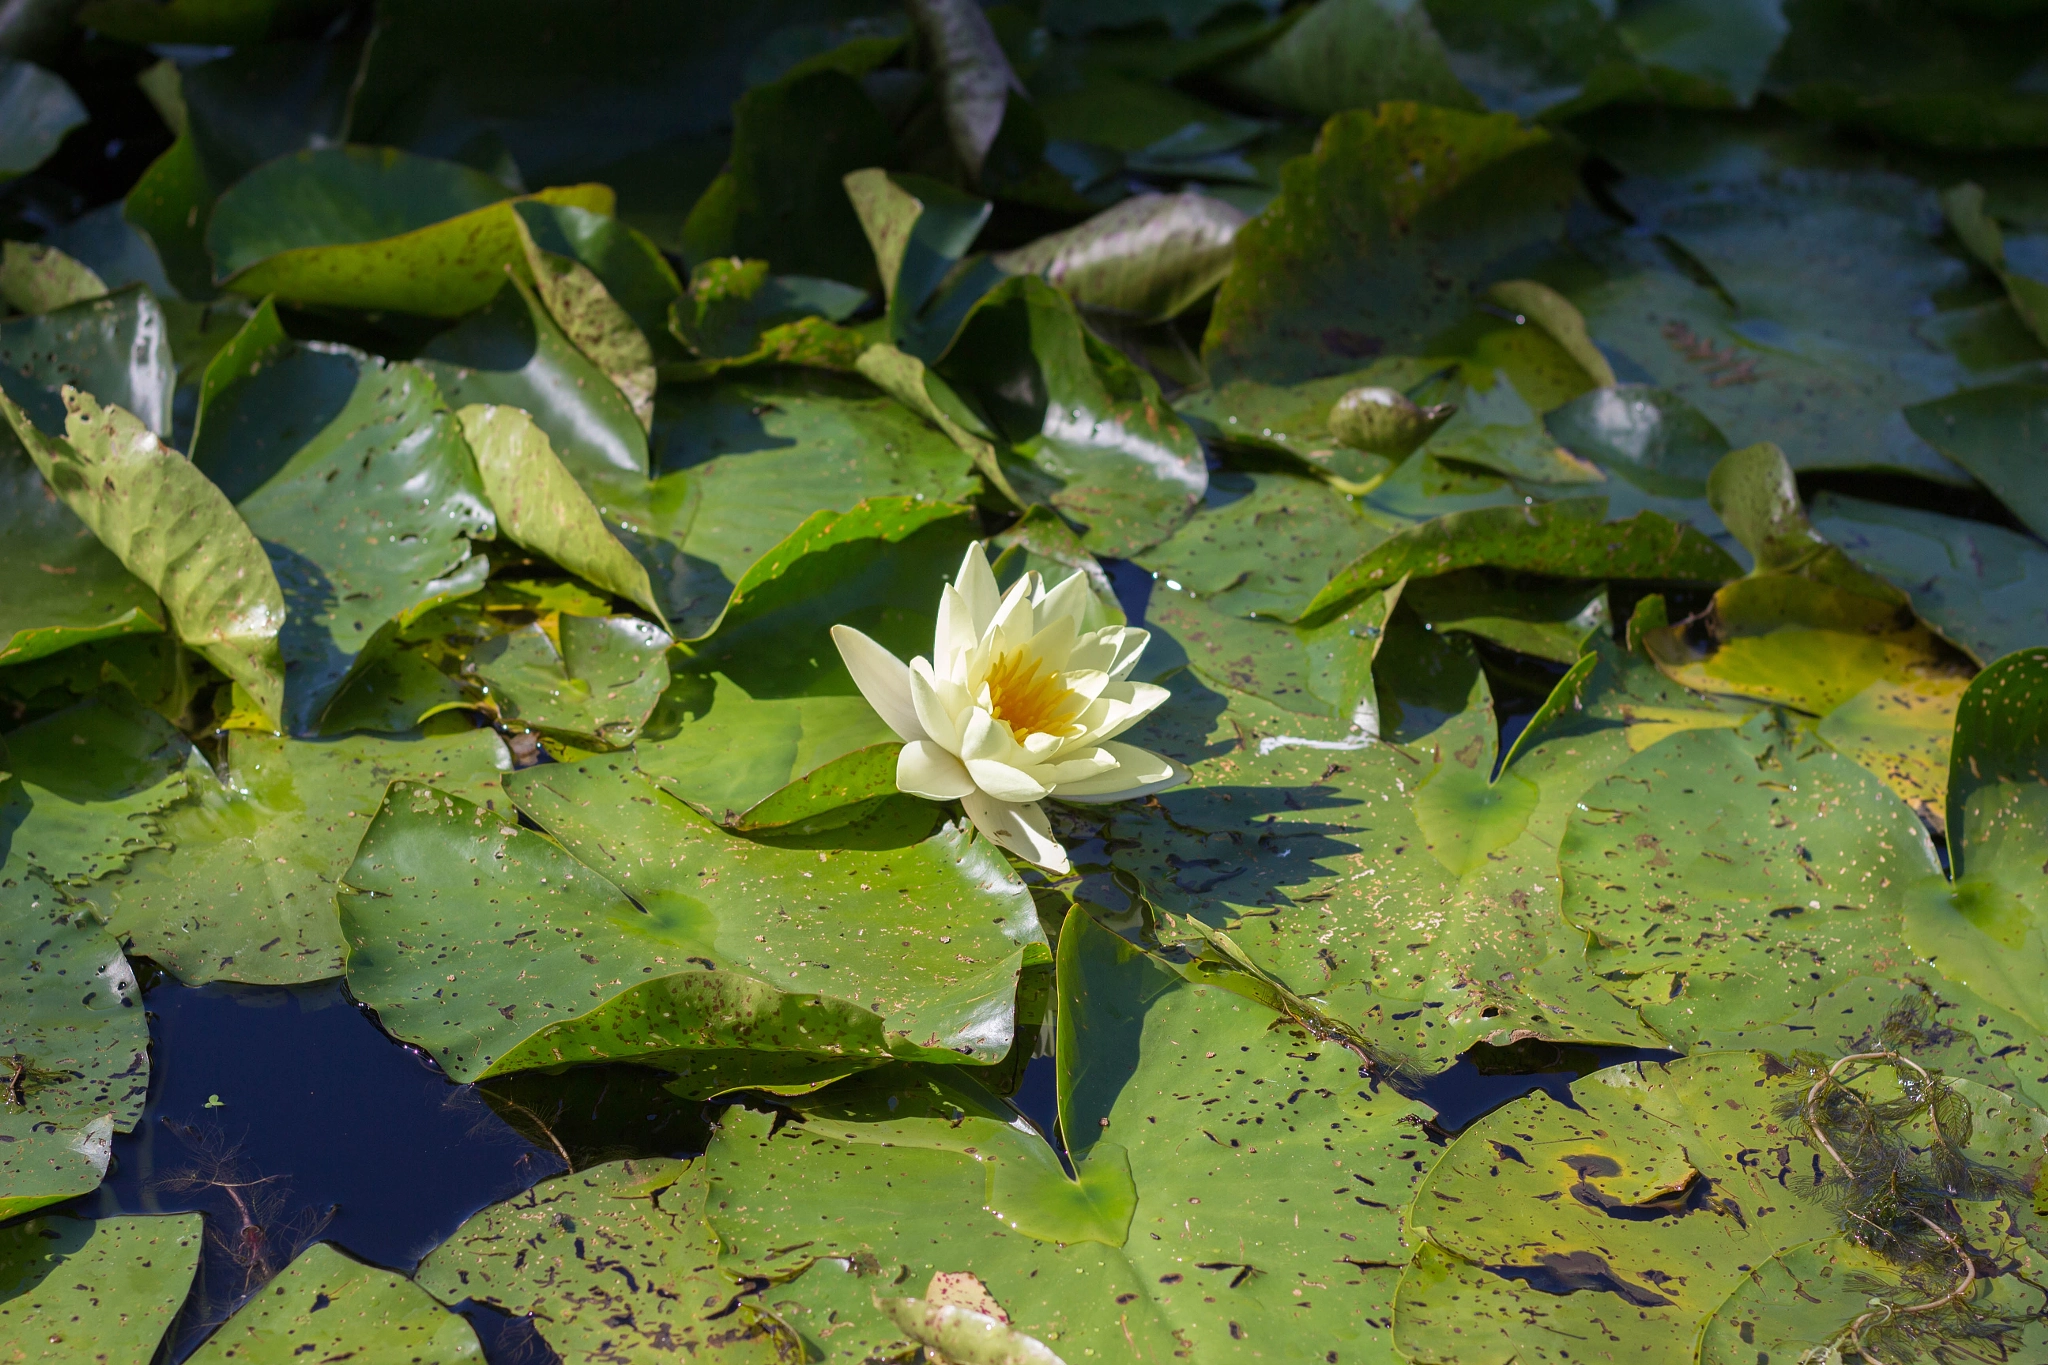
[831,544,1188,872]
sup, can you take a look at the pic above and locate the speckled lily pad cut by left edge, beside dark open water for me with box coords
[0,879,149,1219]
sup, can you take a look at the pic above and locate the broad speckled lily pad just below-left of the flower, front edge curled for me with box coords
[342,759,1044,1078]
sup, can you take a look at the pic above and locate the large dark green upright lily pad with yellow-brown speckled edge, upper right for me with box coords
[1202,102,1577,383]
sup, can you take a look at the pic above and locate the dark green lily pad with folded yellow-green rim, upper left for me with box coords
[207,147,612,317]
